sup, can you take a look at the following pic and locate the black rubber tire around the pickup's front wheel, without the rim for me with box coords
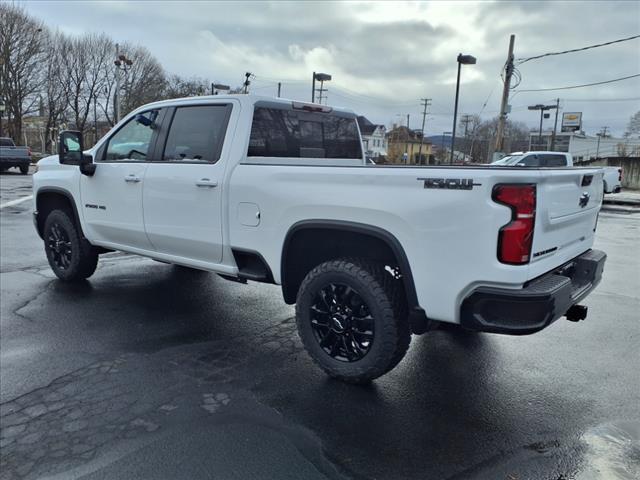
[43,210,98,282]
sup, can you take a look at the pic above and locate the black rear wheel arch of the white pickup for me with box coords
[280,220,430,333]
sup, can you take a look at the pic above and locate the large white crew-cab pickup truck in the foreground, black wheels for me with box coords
[33,95,606,383]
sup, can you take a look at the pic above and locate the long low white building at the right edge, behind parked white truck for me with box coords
[529,131,640,162]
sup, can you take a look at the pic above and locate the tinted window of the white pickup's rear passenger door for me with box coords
[162,104,230,163]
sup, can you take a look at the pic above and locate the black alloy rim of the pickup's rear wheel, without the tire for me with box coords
[309,283,375,362]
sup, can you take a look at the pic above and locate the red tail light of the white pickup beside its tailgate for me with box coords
[491,183,536,265]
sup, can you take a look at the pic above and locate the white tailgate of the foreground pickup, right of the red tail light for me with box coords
[529,168,603,278]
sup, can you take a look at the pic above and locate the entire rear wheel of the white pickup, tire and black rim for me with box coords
[296,258,411,384]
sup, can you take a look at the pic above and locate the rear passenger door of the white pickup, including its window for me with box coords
[143,102,232,264]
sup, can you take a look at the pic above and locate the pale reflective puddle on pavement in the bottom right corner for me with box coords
[576,421,640,480]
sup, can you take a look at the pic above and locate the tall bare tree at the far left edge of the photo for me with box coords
[0,3,48,143]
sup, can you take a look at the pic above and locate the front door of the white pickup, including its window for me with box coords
[80,109,164,250]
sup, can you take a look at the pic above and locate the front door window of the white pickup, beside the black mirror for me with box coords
[104,110,158,161]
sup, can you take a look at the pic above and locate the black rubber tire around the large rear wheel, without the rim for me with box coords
[296,258,411,384]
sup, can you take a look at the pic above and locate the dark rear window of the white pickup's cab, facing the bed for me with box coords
[247,107,362,159]
